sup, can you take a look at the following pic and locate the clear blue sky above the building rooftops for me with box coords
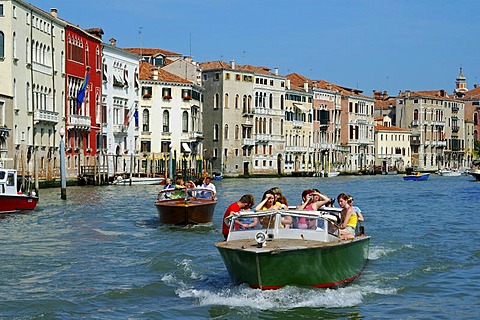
[27,0,480,96]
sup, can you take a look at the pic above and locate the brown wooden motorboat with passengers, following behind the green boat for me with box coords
[155,188,217,225]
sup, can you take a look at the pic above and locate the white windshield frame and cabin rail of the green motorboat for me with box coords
[225,208,341,241]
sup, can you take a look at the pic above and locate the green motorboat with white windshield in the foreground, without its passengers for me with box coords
[215,208,370,290]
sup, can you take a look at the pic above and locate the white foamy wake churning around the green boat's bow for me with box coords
[162,260,395,312]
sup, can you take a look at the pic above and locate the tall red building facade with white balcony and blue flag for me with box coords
[65,24,103,174]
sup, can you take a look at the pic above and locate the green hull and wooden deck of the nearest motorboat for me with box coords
[215,236,370,290]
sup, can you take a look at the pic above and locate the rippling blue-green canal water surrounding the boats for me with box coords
[0,174,480,319]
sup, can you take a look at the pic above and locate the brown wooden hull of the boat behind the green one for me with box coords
[155,199,217,225]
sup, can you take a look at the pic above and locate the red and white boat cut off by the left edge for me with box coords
[0,168,38,214]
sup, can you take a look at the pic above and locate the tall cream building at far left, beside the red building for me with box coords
[0,0,65,181]
